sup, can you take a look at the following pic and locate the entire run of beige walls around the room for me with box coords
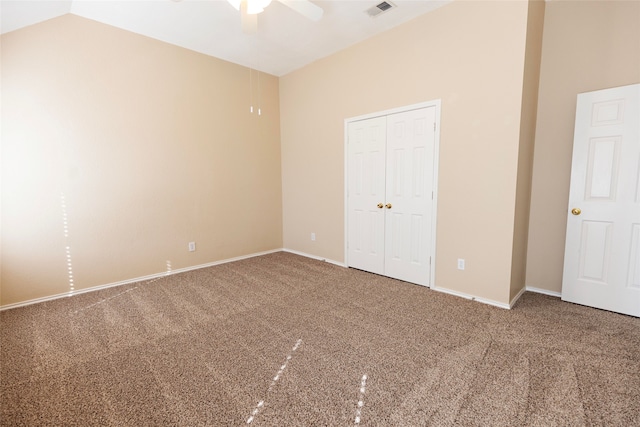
[5,0,640,305]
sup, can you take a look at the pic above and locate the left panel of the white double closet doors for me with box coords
[347,117,387,274]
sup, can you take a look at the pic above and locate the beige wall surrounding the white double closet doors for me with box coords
[280,1,528,303]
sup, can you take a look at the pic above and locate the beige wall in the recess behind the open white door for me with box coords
[526,1,640,292]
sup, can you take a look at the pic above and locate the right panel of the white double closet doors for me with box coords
[385,107,435,286]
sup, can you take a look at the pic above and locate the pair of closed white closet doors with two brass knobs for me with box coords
[347,106,436,286]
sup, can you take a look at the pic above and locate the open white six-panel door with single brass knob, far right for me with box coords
[562,84,640,317]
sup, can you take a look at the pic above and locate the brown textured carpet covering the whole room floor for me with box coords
[0,253,640,427]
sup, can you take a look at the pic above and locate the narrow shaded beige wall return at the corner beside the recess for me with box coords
[509,0,545,301]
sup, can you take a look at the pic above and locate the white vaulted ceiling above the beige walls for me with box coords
[0,0,451,76]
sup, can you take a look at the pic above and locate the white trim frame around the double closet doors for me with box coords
[343,99,442,287]
